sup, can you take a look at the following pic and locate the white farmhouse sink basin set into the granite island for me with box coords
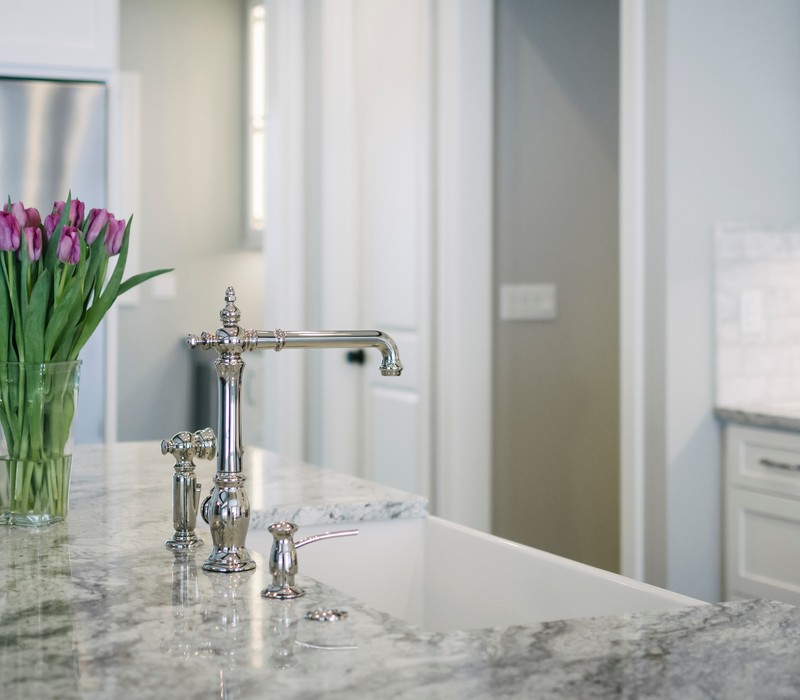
[248,516,702,632]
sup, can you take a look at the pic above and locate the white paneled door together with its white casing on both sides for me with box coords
[263,0,493,530]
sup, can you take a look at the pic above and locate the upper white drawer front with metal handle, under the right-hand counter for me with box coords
[725,426,800,498]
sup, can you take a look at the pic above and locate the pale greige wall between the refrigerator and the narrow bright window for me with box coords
[119,0,263,440]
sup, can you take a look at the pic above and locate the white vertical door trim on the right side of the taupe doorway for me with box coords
[619,0,652,586]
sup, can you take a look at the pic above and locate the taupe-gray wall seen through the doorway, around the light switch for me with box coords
[493,0,619,570]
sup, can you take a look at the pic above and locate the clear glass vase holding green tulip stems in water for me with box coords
[0,360,81,527]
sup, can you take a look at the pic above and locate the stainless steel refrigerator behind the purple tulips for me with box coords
[0,78,108,442]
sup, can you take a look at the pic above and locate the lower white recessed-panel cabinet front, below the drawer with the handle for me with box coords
[725,489,800,605]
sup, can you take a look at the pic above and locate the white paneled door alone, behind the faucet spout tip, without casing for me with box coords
[356,0,433,496]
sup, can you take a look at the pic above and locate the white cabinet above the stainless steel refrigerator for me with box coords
[0,0,119,79]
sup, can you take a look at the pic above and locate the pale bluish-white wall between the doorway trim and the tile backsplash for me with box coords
[644,0,800,600]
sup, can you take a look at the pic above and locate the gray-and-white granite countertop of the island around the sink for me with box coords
[0,444,800,700]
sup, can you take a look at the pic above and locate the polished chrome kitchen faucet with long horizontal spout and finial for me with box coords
[180,287,403,573]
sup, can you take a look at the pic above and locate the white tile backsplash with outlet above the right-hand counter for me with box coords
[714,224,800,406]
